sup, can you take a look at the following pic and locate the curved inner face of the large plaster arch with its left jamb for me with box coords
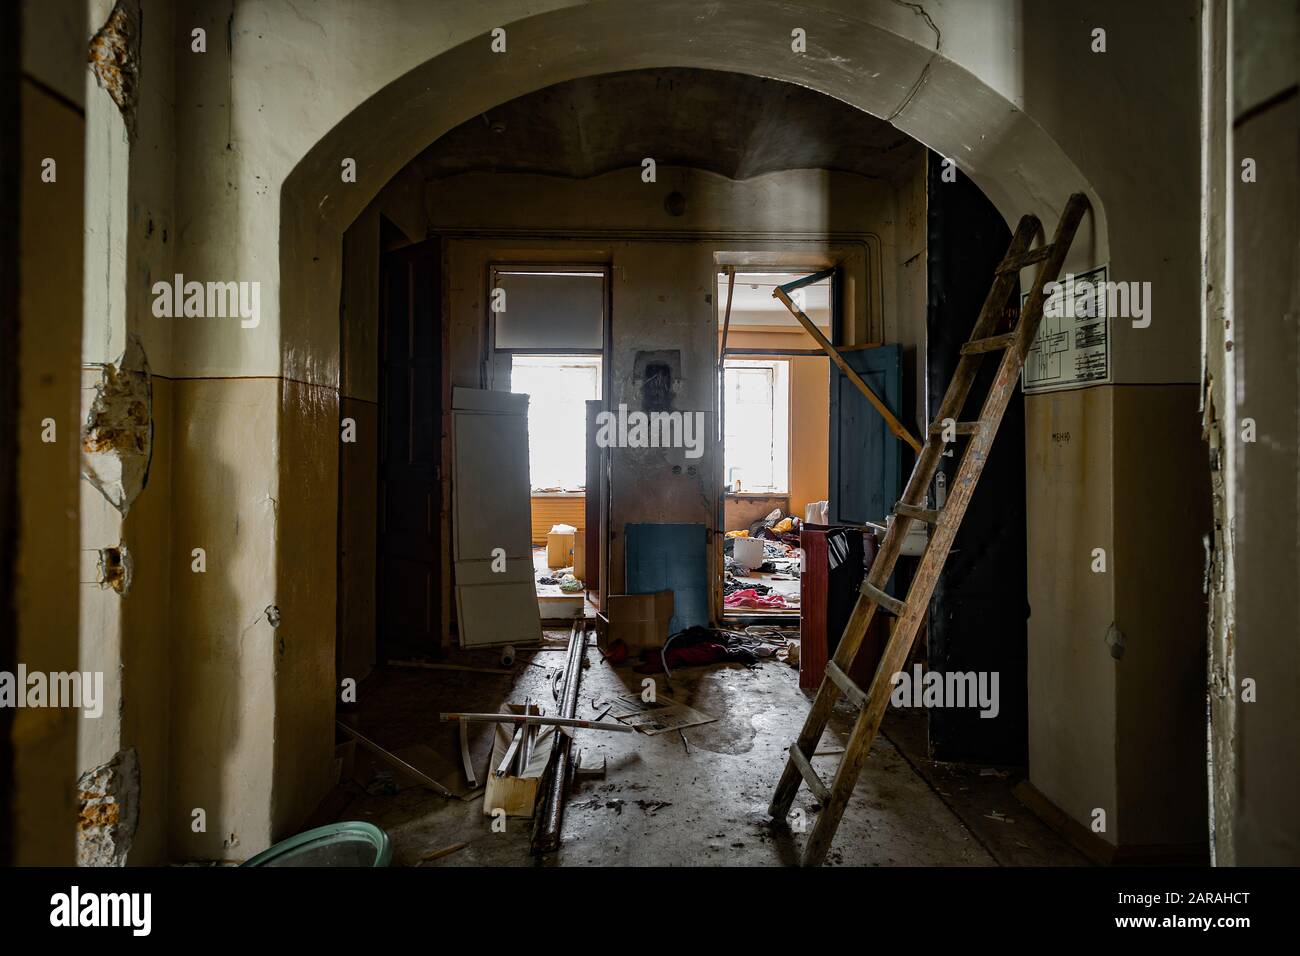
[276,3,1106,848]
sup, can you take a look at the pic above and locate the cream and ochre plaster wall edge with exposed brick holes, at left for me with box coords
[78,0,176,864]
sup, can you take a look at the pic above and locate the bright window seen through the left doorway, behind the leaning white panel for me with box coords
[510,355,601,492]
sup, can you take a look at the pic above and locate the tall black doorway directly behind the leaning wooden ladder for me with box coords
[926,153,1030,765]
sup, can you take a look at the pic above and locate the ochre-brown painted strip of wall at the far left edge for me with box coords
[14,79,82,866]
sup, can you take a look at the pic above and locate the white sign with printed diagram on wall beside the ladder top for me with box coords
[1021,265,1110,393]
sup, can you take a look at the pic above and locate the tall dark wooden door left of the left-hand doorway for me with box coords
[377,239,442,659]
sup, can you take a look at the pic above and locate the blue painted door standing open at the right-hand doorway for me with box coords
[831,345,904,524]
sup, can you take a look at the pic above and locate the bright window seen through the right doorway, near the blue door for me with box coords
[723,359,790,494]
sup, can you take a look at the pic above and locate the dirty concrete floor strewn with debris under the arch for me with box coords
[327,632,1083,866]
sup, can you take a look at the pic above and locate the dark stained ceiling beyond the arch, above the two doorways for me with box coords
[416,69,923,179]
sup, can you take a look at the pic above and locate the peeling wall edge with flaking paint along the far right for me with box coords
[1203,0,1300,866]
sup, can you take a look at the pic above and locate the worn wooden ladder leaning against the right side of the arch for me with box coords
[770,193,1088,866]
